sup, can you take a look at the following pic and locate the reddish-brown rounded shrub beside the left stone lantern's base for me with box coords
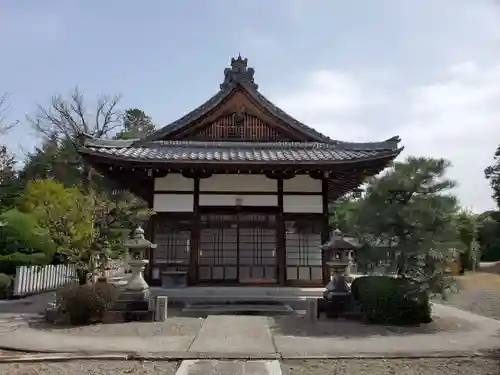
[56,282,119,325]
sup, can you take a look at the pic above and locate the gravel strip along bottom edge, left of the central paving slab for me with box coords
[0,361,179,375]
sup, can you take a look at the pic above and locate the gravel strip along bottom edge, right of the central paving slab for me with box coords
[281,358,500,375]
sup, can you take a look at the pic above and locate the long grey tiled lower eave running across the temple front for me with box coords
[80,139,401,164]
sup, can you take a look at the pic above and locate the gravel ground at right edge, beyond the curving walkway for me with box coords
[438,272,500,320]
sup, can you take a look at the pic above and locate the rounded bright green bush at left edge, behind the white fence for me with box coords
[0,209,54,274]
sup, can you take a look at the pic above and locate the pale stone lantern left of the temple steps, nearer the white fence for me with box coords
[123,226,156,298]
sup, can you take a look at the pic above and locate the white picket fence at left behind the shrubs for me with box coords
[13,264,77,297]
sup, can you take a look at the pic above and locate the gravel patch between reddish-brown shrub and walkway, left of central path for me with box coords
[31,317,205,337]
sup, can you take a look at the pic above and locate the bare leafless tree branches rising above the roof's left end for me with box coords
[28,87,122,139]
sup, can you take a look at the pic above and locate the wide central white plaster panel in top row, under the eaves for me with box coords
[200,174,278,193]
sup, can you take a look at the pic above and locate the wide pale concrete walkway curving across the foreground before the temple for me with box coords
[0,305,500,360]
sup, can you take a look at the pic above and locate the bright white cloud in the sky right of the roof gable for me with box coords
[276,61,500,211]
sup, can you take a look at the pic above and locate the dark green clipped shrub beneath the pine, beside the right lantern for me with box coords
[351,276,432,325]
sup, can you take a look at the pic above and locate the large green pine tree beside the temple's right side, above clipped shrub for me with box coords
[340,157,459,292]
